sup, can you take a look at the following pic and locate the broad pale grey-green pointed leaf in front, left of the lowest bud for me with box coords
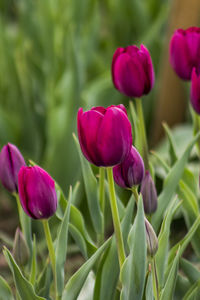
[120,195,147,300]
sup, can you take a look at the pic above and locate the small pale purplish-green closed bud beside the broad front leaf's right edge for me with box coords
[145,218,158,257]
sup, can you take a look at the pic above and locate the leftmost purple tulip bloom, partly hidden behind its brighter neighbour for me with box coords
[0,143,26,193]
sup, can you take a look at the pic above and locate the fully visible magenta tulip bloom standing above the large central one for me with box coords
[112,45,154,97]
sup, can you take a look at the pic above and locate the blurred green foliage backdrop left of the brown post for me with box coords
[0,0,170,192]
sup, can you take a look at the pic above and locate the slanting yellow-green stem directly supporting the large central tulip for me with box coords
[107,167,126,269]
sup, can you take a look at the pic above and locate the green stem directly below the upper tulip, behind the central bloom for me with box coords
[135,98,149,170]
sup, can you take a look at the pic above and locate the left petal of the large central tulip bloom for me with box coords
[78,108,104,166]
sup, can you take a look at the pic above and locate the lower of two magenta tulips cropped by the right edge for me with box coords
[190,68,200,114]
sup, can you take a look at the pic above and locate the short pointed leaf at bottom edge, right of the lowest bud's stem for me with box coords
[160,248,180,300]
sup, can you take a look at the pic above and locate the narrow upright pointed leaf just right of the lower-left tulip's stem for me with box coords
[55,187,72,296]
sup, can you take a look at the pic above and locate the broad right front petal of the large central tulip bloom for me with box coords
[97,107,132,166]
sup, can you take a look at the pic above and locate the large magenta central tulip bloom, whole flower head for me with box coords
[78,105,132,167]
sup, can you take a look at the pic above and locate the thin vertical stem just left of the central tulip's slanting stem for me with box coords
[98,168,105,245]
